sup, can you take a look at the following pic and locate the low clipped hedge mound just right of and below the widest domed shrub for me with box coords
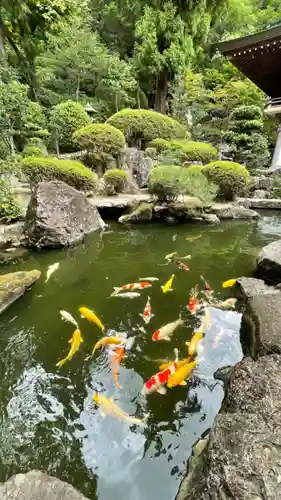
[169,140,219,163]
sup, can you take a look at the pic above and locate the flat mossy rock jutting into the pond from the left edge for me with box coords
[0,269,41,314]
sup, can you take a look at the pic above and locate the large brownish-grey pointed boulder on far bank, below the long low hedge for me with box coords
[24,181,105,248]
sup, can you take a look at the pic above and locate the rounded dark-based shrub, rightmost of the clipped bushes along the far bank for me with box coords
[203,161,249,200]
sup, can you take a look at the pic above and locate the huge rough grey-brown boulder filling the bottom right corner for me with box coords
[177,354,281,500]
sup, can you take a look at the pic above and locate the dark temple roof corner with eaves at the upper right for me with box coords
[216,25,281,98]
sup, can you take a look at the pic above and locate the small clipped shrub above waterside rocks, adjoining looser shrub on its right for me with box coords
[147,165,182,201]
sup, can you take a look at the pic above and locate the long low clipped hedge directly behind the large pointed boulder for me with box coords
[22,156,98,191]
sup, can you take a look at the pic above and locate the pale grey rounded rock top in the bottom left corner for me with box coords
[0,470,87,500]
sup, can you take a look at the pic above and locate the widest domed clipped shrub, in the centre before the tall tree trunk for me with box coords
[107,109,189,149]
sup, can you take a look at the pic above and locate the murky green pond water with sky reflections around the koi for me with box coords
[0,212,281,500]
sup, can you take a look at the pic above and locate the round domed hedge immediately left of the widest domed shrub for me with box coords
[73,123,126,157]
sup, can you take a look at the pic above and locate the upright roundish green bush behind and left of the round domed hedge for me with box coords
[50,100,91,151]
